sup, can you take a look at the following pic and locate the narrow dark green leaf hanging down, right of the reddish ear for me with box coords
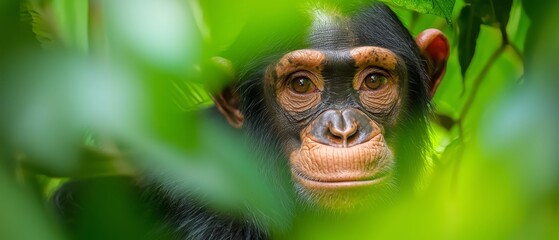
[458,6,481,81]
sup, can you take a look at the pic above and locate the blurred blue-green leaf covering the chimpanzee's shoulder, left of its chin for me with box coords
[125,117,292,230]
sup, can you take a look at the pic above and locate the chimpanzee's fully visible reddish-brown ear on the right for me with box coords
[415,29,450,98]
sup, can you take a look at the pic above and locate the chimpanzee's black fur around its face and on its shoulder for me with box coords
[53,4,429,239]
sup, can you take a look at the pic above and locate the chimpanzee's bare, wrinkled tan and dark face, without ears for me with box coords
[265,47,406,209]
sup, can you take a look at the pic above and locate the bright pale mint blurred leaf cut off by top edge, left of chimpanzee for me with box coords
[103,0,201,74]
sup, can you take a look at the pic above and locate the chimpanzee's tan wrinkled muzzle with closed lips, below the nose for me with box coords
[289,131,394,191]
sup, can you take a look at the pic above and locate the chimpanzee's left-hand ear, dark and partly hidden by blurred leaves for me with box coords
[212,57,244,128]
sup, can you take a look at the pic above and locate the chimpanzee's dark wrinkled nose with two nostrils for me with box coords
[311,108,374,147]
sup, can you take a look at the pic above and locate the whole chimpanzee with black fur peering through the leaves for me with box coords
[55,3,449,239]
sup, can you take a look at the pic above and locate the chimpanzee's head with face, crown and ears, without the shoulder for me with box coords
[215,3,449,209]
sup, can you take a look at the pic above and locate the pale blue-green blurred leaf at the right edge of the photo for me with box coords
[479,84,559,197]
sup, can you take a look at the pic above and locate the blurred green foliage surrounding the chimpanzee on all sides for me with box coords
[0,0,559,239]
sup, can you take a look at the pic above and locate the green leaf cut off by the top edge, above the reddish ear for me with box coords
[381,0,456,23]
